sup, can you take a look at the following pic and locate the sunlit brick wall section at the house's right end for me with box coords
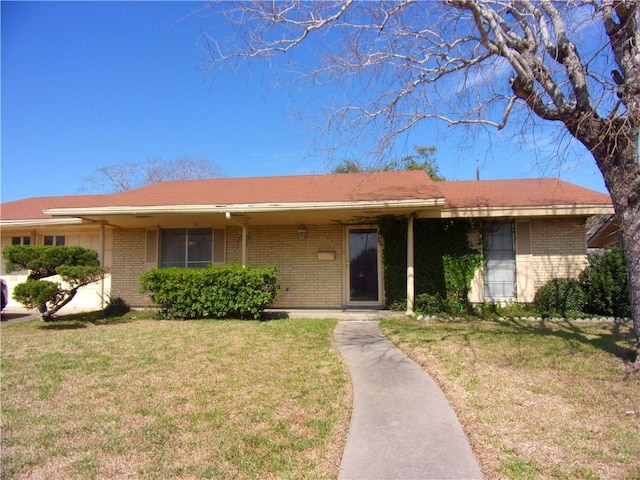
[531,219,587,290]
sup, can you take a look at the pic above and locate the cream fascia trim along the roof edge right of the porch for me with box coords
[442,205,614,218]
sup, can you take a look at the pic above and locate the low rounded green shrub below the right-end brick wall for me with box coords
[534,278,586,316]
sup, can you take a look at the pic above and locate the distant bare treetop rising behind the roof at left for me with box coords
[81,157,222,192]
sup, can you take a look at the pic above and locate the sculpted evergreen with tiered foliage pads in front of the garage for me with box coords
[2,245,106,321]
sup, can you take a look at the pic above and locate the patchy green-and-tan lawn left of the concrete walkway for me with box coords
[1,314,350,479]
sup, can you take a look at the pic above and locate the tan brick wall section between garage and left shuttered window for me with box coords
[111,229,149,307]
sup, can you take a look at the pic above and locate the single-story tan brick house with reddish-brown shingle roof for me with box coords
[0,171,613,310]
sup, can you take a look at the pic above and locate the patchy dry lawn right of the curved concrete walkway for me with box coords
[381,319,640,480]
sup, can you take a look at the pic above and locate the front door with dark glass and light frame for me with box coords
[347,227,382,306]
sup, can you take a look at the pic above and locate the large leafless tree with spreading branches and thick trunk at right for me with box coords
[206,0,640,366]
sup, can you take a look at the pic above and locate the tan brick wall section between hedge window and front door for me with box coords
[246,225,344,308]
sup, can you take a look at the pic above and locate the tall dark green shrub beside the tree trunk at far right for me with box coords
[580,247,631,317]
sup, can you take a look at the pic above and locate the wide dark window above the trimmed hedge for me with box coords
[160,228,224,268]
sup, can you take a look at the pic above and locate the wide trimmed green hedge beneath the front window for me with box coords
[140,265,278,319]
